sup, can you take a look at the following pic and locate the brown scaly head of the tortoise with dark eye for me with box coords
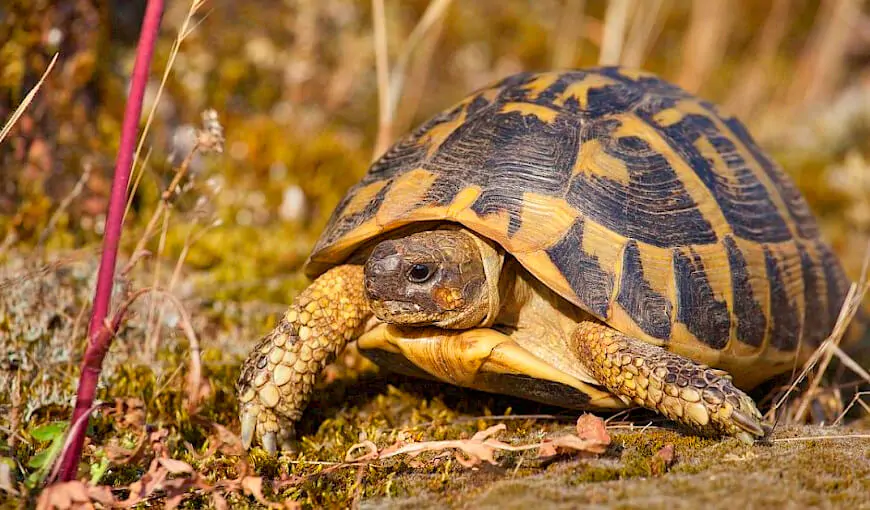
[365,229,503,329]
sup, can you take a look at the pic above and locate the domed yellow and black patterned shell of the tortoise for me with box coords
[307,67,848,378]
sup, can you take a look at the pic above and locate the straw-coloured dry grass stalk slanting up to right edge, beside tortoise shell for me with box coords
[770,243,870,421]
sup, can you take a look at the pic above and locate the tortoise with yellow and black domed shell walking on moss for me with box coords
[237,67,849,452]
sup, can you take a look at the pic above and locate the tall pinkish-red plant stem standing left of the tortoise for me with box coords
[59,0,163,482]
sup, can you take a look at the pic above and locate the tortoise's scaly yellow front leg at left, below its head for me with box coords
[236,265,371,453]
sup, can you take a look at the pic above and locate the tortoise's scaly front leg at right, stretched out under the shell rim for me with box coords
[572,321,770,444]
